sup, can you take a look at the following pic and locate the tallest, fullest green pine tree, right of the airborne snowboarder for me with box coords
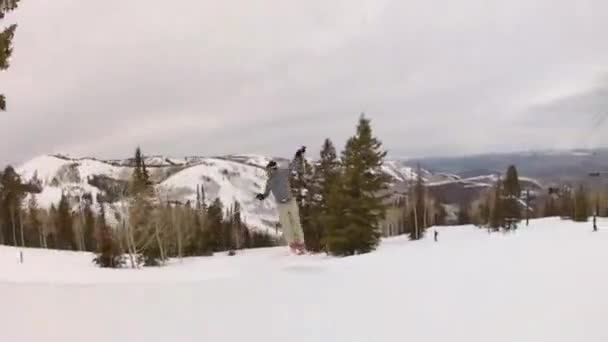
[328,115,388,255]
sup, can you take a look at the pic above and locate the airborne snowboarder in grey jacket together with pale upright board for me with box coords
[256,146,306,254]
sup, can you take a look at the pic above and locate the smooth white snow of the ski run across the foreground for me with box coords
[0,219,608,342]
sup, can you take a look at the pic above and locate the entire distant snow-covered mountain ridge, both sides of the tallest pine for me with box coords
[11,154,540,232]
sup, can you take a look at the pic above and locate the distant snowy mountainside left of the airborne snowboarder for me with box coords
[17,155,277,232]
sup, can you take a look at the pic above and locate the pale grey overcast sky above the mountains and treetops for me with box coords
[0,0,608,163]
